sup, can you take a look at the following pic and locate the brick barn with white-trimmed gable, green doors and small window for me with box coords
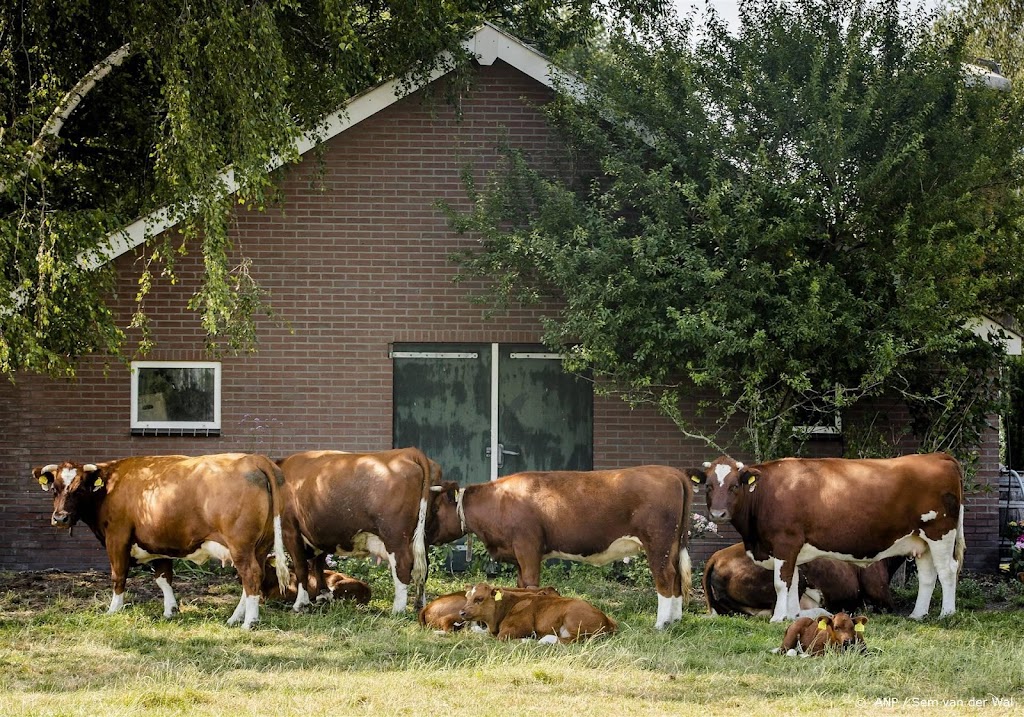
[0,27,998,571]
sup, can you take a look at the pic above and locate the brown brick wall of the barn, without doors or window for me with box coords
[0,62,995,570]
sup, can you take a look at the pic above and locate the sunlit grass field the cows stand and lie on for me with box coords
[0,561,1024,717]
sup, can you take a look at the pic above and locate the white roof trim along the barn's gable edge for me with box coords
[79,24,582,269]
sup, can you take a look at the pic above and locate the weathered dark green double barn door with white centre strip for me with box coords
[391,343,594,486]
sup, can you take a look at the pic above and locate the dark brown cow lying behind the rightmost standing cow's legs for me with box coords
[701,543,903,616]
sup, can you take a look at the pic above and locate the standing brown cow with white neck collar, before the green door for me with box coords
[428,465,693,629]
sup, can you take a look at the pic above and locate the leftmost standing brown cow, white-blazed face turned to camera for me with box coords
[32,454,288,630]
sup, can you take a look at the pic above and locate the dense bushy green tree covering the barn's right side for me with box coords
[453,0,1024,459]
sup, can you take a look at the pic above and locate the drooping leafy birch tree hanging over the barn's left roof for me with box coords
[0,0,662,376]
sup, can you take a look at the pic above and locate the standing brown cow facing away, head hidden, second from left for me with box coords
[279,448,436,613]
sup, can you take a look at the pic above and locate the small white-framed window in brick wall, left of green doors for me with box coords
[131,361,220,435]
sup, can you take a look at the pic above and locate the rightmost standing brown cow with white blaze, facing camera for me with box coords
[690,453,964,622]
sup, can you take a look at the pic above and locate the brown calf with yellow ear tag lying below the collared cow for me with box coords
[460,583,618,643]
